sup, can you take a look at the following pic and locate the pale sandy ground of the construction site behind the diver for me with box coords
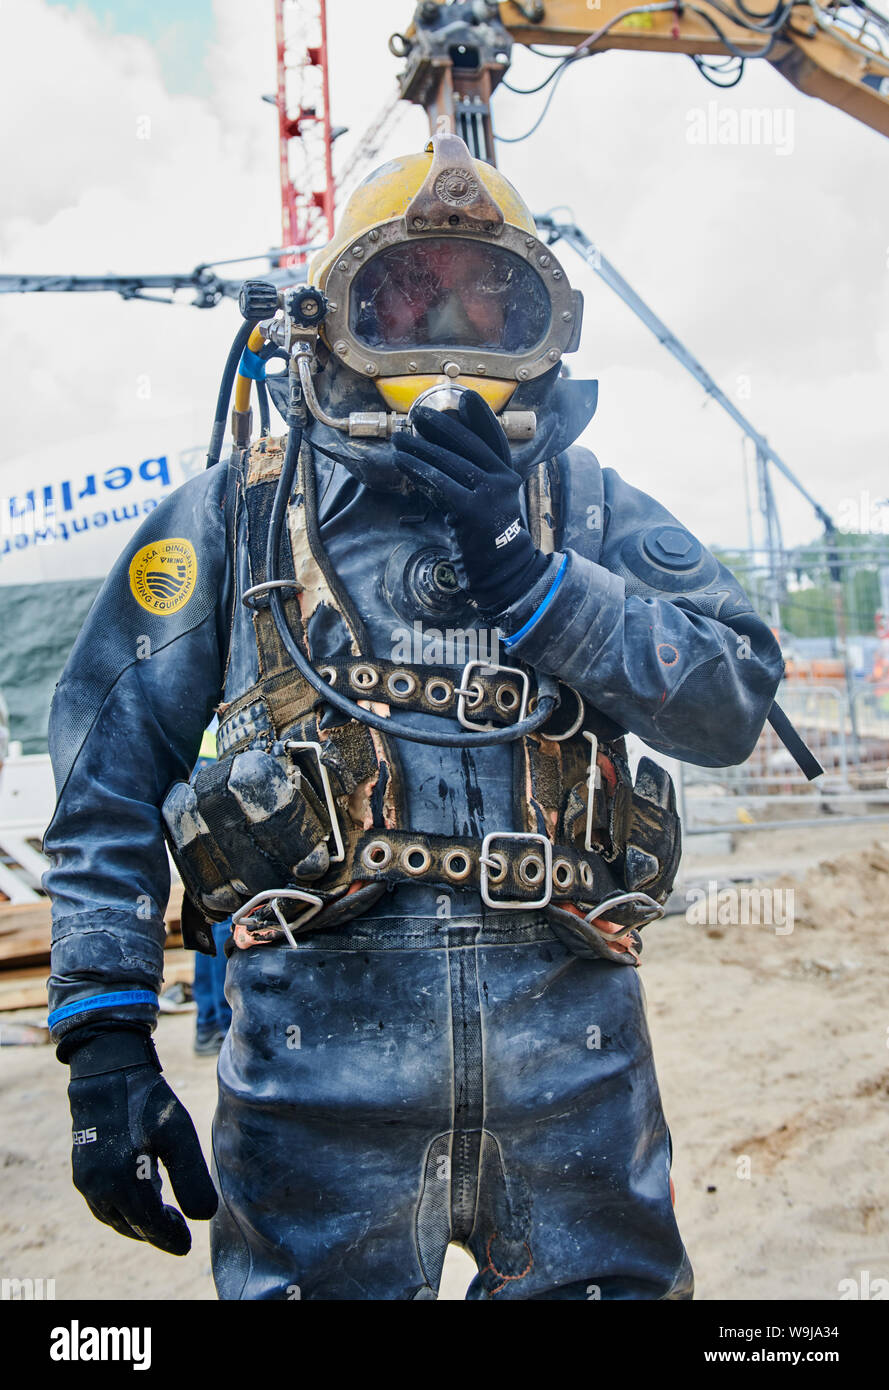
[0,824,889,1300]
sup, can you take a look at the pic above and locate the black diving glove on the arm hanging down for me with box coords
[67,1029,218,1255]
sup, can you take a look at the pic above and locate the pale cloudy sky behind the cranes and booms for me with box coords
[0,0,889,546]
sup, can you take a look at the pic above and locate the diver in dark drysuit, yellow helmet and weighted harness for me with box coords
[44,133,782,1300]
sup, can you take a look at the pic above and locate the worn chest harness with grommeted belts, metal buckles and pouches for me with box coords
[163,438,679,965]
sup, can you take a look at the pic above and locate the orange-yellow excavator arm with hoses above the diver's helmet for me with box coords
[389,0,889,156]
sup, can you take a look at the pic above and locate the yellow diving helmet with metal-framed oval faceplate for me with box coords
[308,135,583,413]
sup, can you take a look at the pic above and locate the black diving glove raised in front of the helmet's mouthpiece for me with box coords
[393,391,547,614]
